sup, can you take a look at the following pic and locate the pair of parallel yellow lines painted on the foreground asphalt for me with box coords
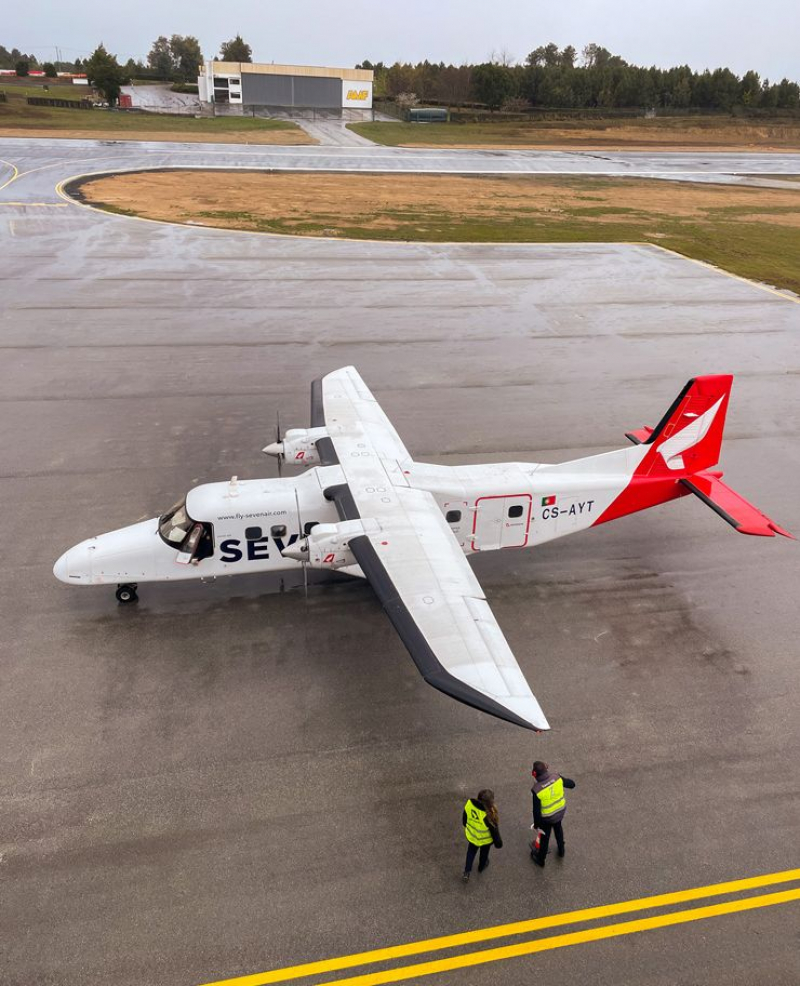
[198,869,800,986]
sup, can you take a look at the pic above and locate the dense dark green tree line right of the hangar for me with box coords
[356,42,800,112]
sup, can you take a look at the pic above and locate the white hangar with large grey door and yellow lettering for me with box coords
[197,62,373,119]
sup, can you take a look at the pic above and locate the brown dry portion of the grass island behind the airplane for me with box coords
[82,171,800,231]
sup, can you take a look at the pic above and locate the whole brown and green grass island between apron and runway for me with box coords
[75,171,800,294]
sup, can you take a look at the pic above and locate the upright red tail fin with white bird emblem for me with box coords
[628,374,733,479]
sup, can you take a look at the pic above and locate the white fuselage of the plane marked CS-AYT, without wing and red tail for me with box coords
[54,446,644,585]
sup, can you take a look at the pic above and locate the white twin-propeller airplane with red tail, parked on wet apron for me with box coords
[53,366,793,731]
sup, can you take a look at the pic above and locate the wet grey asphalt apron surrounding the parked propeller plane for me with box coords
[0,141,800,986]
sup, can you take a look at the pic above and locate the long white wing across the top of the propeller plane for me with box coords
[312,367,550,730]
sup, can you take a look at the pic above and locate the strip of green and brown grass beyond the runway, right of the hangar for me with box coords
[348,117,800,150]
